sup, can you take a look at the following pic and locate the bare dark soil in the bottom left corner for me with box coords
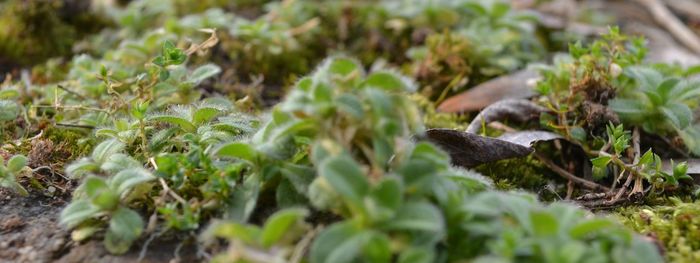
[0,189,196,263]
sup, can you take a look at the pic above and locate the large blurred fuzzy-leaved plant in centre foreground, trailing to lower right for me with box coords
[205,58,661,262]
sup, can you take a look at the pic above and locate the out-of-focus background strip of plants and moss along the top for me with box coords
[0,0,700,98]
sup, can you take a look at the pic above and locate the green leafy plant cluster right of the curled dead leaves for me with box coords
[536,28,698,203]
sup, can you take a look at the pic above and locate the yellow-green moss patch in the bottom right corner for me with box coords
[616,197,700,262]
